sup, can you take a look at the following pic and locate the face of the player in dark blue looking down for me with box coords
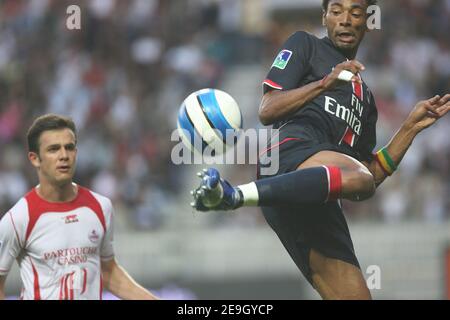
[323,0,367,56]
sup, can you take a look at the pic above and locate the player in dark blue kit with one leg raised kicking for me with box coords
[192,0,450,299]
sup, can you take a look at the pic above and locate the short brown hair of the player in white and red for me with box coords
[27,114,77,154]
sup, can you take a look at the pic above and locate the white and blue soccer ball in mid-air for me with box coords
[177,89,242,156]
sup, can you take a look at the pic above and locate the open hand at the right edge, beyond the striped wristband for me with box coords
[405,94,450,132]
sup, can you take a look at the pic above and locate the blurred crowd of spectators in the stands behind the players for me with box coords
[0,0,450,230]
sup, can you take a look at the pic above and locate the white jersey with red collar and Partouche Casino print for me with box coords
[0,186,114,300]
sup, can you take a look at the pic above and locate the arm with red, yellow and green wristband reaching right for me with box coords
[365,94,450,186]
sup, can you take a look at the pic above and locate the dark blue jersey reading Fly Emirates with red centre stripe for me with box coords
[263,31,378,161]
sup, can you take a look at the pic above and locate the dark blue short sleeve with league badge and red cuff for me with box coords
[263,32,312,93]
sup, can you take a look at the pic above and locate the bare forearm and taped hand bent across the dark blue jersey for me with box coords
[259,60,365,125]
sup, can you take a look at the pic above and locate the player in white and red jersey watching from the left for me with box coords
[0,114,157,300]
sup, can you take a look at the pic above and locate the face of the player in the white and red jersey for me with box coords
[28,128,77,185]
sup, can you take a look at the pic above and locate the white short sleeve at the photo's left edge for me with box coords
[0,212,22,275]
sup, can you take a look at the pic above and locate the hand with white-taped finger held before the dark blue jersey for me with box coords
[322,60,366,90]
